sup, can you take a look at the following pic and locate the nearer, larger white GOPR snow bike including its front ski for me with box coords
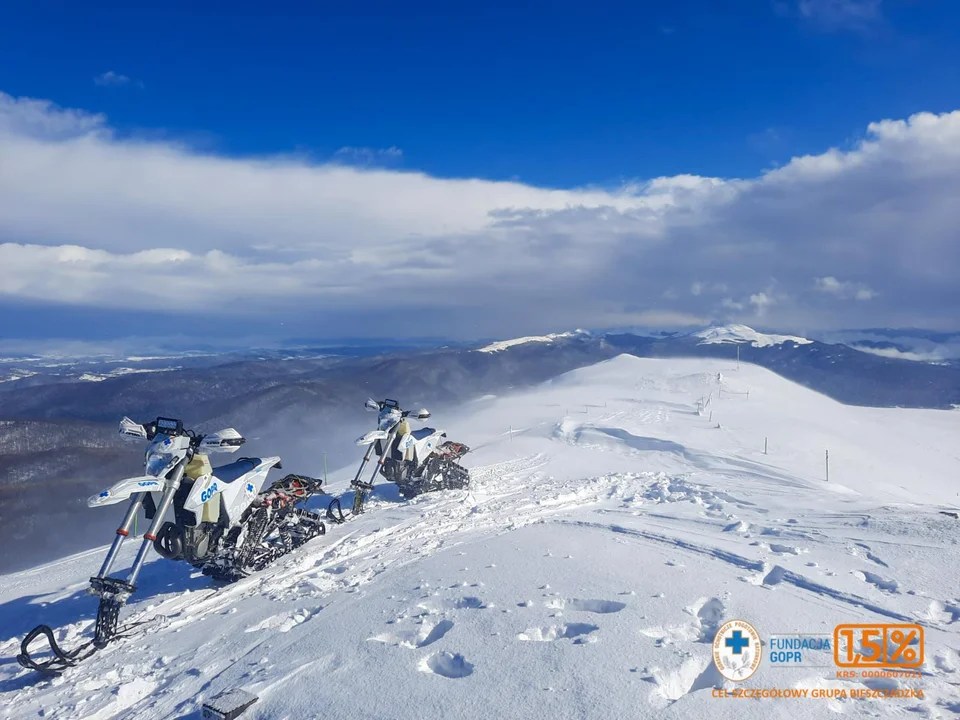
[17,417,343,674]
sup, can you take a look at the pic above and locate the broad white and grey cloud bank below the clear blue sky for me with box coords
[0,94,960,336]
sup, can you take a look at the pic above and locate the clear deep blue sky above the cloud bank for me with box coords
[0,0,960,187]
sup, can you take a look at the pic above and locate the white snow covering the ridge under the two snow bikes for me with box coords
[0,356,960,720]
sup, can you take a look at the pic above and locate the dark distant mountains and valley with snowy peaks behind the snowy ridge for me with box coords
[0,325,960,571]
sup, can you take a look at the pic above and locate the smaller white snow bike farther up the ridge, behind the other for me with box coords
[351,399,470,513]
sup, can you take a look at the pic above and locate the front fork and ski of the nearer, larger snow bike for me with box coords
[17,460,186,674]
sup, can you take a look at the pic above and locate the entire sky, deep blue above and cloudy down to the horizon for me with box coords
[0,0,960,348]
